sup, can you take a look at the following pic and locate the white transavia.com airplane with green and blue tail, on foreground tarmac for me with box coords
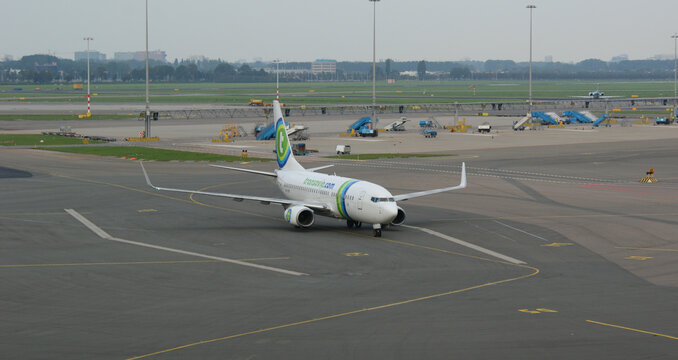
[139,101,466,237]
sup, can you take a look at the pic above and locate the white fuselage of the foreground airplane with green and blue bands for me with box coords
[277,170,398,224]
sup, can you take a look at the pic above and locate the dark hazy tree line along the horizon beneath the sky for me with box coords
[0,55,673,84]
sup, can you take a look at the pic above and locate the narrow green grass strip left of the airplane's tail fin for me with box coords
[39,146,272,161]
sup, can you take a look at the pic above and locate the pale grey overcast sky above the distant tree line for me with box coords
[0,0,678,62]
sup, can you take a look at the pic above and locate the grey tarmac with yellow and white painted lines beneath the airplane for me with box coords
[0,111,678,359]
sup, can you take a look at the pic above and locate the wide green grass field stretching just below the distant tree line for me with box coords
[0,80,673,105]
